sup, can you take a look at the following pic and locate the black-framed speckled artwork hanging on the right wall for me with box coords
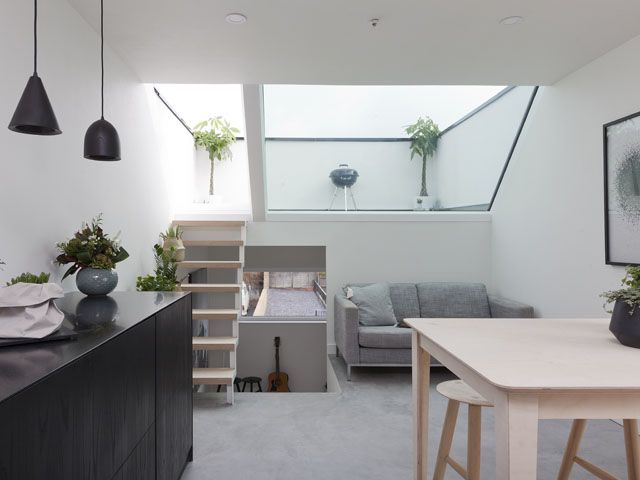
[603,112,640,265]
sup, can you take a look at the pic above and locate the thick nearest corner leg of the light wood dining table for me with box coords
[495,394,538,480]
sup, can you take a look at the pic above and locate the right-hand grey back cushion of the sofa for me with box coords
[417,283,491,318]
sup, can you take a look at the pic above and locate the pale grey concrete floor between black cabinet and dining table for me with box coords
[183,358,626,480]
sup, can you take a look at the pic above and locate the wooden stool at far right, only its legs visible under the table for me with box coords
[558,419,640,480]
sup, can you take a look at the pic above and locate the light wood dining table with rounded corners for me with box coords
[405,318,640,480]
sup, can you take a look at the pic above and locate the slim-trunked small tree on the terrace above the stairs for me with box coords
[193,117,239,201]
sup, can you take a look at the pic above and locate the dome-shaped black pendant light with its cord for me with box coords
[84,0,120,161]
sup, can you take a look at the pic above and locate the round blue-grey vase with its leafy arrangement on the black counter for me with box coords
[56,215,129,295]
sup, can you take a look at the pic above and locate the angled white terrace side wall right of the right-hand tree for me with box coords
[436,87,533,208]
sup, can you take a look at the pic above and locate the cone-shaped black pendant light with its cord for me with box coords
[9,0,62,135]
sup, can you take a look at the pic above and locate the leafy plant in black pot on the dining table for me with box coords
[601,266,640,348]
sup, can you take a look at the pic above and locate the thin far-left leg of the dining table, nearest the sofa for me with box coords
[411,331,431,480]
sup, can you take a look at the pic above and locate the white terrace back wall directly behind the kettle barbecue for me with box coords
[265,141,433,210]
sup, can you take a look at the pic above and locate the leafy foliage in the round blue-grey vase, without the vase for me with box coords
[56,214,129,280]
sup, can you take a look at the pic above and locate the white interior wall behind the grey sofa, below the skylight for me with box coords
[247,218,491,352]
